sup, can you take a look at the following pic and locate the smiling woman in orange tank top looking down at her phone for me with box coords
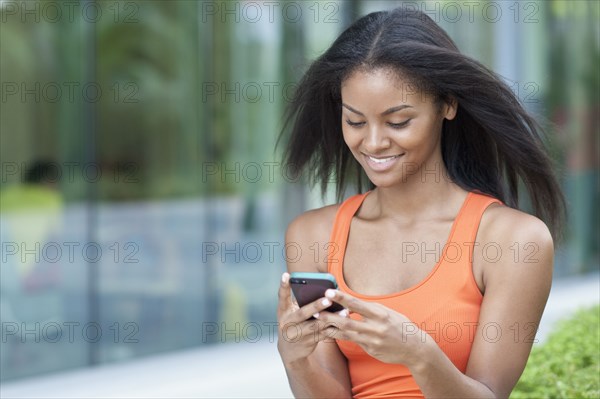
[278,8,564,398]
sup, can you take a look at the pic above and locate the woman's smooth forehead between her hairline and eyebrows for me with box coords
[341,68,432,106]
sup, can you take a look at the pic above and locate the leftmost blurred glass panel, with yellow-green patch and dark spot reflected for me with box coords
[0,2,88,381]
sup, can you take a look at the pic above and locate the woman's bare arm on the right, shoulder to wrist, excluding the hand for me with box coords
[411,207,554,398]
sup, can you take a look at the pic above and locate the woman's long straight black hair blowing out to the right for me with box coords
[276,7,565,242]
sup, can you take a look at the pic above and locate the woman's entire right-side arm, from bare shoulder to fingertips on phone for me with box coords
[319,207,554,398]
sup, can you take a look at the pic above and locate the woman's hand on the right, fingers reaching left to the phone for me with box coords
[318,289,430,365]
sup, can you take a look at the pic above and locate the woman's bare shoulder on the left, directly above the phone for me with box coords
[285,204,340,272]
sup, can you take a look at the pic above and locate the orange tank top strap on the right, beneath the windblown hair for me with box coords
[448,191,502,246]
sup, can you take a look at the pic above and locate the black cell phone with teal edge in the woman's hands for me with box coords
[290,272,344,312]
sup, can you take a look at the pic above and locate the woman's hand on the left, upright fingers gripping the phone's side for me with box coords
[277,273,337,363]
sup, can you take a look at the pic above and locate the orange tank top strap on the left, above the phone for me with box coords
[327,190,372,275]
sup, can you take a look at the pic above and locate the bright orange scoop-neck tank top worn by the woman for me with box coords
[327,191,502,398]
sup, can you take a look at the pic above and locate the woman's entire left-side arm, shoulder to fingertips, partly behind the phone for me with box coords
[277,209,352,398]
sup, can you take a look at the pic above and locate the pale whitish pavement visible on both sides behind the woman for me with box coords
[0,273,600,399]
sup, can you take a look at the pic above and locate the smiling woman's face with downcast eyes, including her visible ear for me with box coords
[341,69,456,187]
